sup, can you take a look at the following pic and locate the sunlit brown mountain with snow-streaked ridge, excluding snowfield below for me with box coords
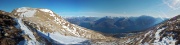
[12,7,109,39]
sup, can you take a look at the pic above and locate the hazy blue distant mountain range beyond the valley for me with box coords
[65,15,167,34]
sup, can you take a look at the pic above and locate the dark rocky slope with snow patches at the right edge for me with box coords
[119,15,180,45]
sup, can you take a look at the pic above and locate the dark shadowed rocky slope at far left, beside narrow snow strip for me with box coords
[0,12,24,45]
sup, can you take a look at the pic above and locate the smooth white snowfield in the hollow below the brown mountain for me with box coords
[38,30,87,44]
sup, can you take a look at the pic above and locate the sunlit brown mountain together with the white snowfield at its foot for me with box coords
[10,7,115,45]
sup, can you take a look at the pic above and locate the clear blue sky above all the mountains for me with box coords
[0,0,180,17]
